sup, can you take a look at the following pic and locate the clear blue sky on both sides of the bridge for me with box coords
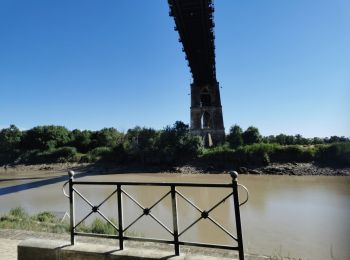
[0,0,350,137]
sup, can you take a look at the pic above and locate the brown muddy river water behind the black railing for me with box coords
[0,173,350,260]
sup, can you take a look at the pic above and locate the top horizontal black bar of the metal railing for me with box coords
[73,181,232,188]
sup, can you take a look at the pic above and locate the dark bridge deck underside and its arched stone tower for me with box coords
[168,0,225,146]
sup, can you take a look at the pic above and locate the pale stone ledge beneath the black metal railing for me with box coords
[18,238,238,260]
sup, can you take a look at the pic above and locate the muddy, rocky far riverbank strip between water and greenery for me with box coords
[0,163,350,178]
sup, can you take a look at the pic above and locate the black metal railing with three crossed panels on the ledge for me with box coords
[63,171,249,260]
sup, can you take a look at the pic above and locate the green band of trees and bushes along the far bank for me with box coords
[0,121,350,166]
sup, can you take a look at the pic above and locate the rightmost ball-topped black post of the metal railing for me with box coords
[230,171,244,260]
